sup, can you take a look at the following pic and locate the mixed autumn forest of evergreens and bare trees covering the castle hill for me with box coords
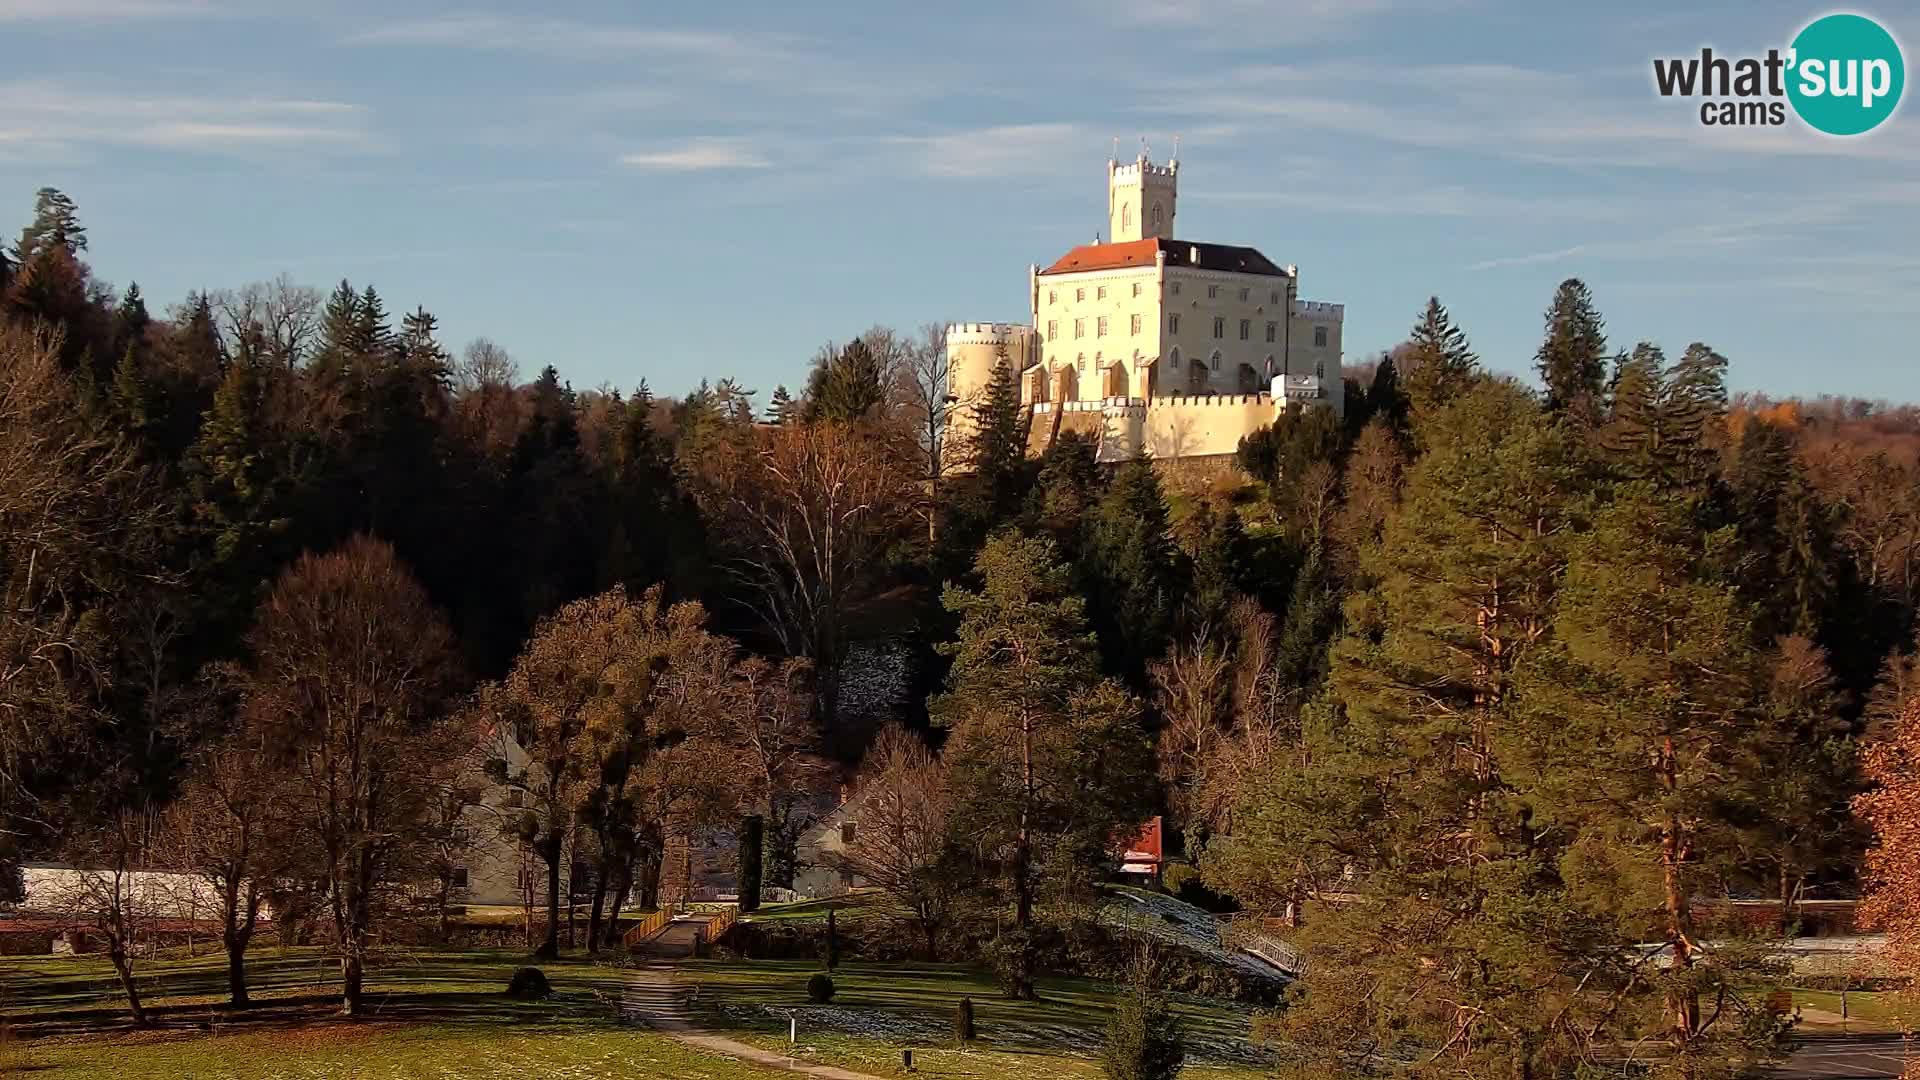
[0,180,1920,1078]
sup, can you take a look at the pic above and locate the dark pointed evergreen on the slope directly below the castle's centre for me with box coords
[1081,455,1187,686]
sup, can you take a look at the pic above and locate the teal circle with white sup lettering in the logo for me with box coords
[1788,15,1907,135]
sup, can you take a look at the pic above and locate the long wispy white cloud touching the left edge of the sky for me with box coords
[0,83,371,158]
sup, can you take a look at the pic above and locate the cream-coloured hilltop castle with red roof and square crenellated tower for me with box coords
[947,154,1344,461]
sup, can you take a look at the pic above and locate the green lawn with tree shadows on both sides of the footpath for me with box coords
[0,945,1261,1080]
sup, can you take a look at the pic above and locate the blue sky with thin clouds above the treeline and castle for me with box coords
[0,0,1920,404]
